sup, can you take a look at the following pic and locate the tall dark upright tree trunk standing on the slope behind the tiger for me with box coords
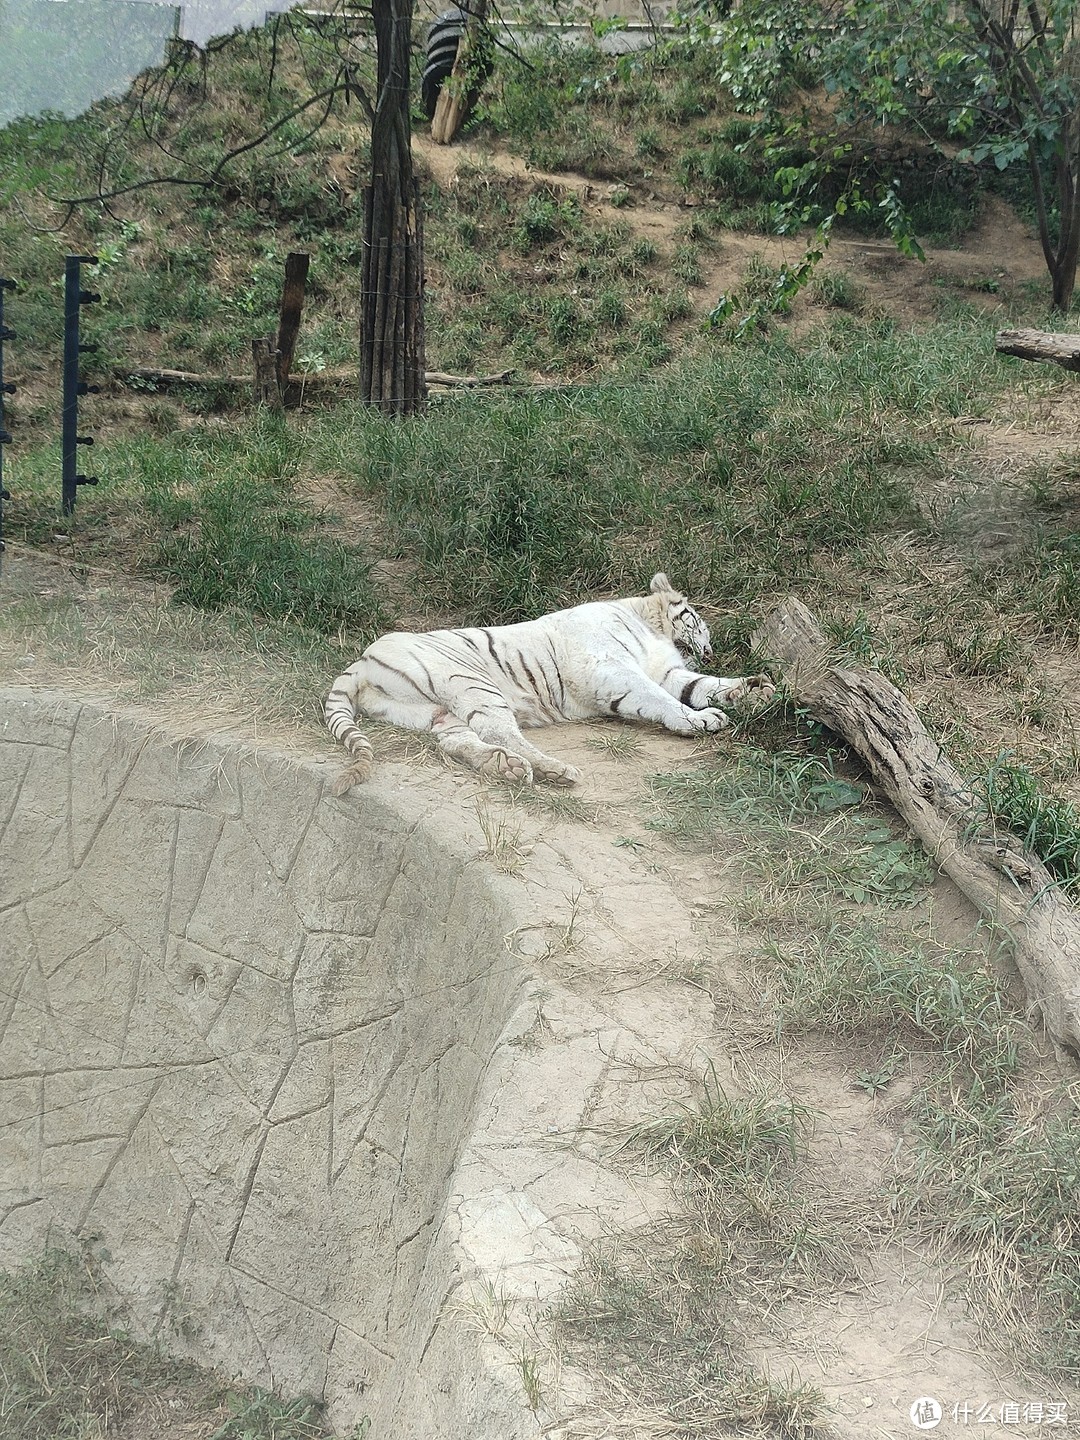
[360,0,426,415]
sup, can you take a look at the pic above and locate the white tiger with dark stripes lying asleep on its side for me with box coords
[325,575,775,795]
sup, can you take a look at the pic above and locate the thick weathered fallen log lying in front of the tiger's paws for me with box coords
[755,596,1080,1057]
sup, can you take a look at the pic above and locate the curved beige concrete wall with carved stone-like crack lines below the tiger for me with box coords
[0,691,532,1440]
